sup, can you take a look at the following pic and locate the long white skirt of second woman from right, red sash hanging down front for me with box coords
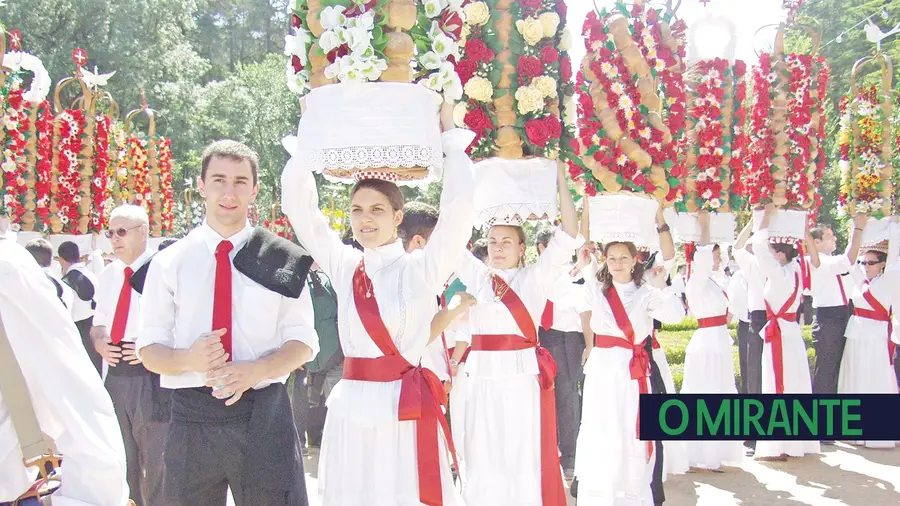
[754,320,821,458]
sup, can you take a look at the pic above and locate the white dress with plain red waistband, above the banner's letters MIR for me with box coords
[681,245,744,469]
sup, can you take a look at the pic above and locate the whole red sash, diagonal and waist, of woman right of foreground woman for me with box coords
[471,274,566,506]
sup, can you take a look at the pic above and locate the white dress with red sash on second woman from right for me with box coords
[751,230,821,458]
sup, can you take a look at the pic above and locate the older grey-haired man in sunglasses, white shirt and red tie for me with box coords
[91,204,171,506]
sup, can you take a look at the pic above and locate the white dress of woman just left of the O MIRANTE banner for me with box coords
[575,275,685,506]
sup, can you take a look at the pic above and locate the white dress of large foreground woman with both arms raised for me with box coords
[282,130,475,506]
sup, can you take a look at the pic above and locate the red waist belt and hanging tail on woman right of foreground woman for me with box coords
[469,334,564,504]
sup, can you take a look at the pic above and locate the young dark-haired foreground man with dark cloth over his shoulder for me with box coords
[136,140,319,506]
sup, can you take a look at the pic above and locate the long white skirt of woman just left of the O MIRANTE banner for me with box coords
[575,347,656,506]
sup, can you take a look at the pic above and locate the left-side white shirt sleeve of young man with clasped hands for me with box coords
[134,256,175,358]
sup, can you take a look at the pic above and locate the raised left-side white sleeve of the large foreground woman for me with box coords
[281,138,359,279]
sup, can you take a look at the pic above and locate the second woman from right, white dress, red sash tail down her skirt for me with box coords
[750,204,820,460]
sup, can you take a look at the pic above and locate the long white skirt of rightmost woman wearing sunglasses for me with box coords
[838,316,897,448]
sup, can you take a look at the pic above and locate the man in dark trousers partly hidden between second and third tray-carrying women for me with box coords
[535,228,586,480]
